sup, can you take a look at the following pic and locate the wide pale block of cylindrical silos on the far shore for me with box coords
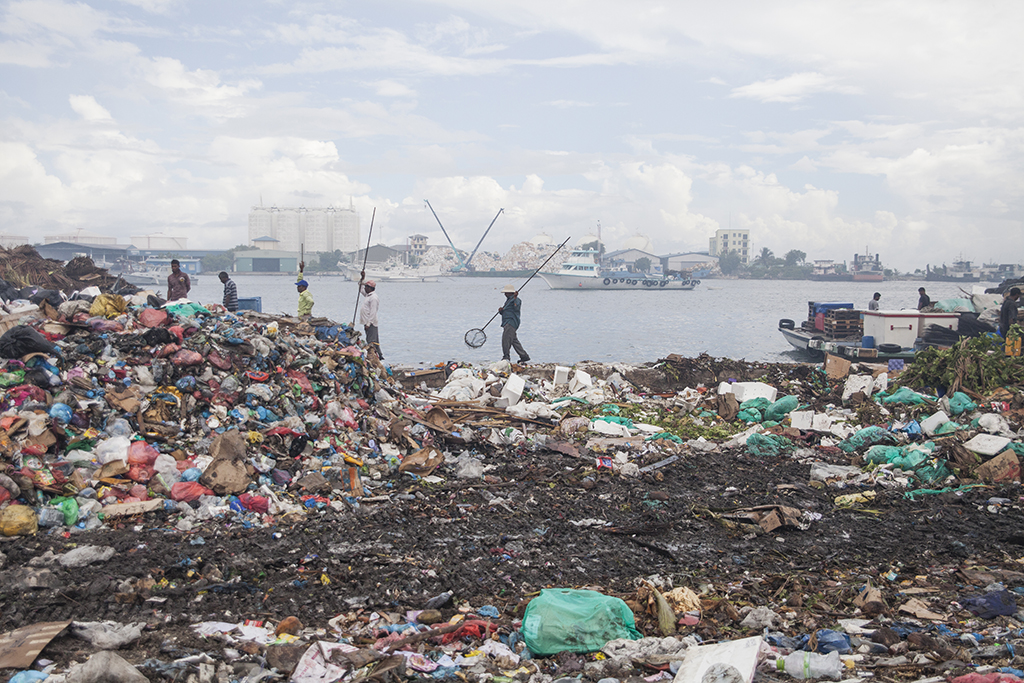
[249,207,359,254]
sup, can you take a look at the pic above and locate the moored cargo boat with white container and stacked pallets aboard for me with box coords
[778,301,959,360]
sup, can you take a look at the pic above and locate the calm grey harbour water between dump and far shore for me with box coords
[186,273,995,366]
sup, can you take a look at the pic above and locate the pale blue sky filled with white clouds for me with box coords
[0,0,1024,270]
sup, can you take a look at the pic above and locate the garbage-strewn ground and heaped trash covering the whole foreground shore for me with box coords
[0,294,1024,683]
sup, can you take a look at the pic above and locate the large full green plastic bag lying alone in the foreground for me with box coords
[521,588,643,656]
